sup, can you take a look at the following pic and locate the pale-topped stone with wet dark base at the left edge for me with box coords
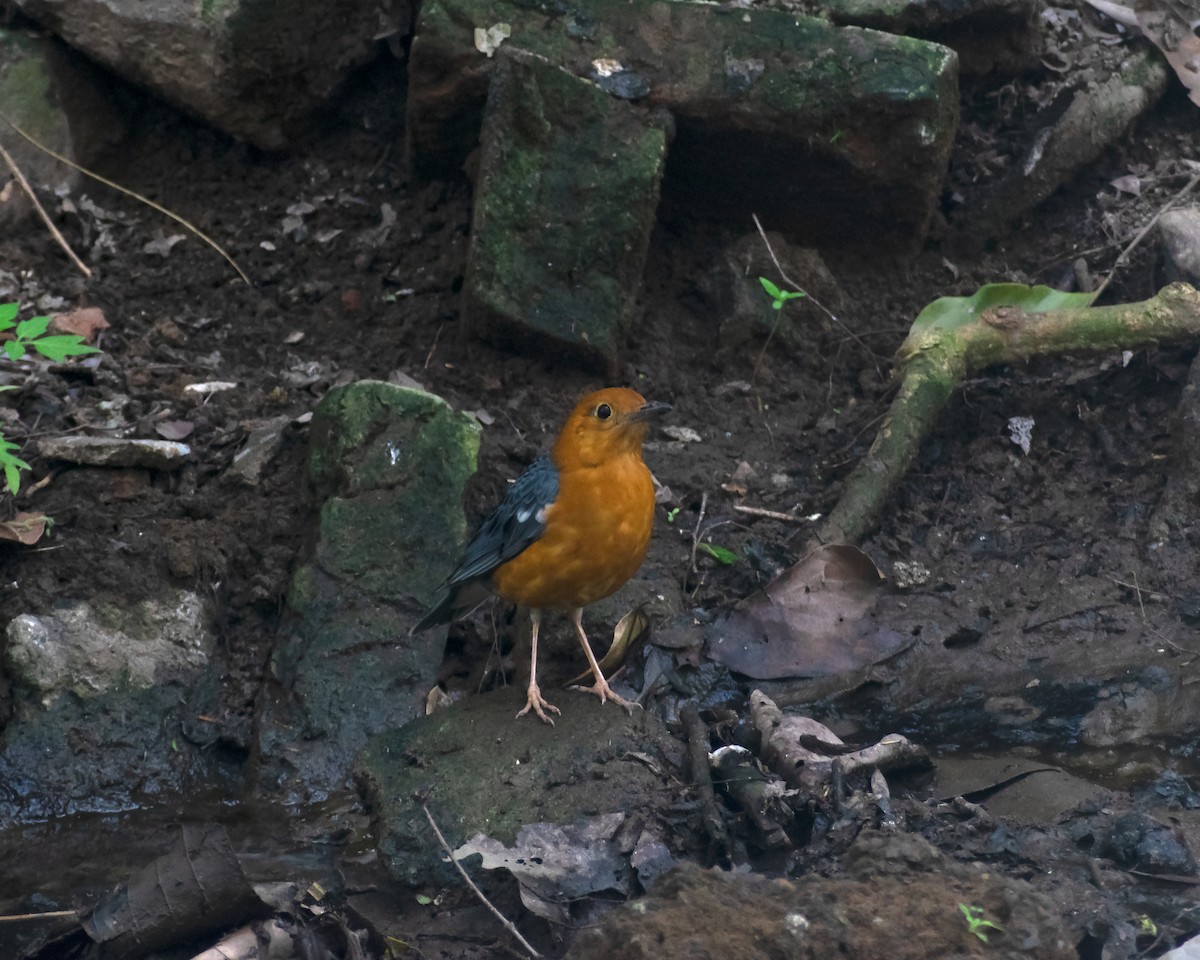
[0,590,229,822]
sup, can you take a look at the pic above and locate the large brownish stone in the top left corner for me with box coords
[17,0,410,150]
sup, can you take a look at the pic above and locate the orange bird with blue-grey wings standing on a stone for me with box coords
[413,386,671,724]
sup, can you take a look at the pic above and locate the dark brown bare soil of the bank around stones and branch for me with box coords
[0,7,1200,956]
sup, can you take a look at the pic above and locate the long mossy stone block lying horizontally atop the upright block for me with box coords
[407,0,959,245]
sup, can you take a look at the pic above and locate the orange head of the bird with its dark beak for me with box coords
[551,386,671,470]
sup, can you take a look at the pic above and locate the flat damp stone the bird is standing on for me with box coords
[355,688,682,886]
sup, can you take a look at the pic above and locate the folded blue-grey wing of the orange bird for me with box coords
[413,454,558,632]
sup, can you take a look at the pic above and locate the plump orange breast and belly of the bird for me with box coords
[492,455,654,610]
